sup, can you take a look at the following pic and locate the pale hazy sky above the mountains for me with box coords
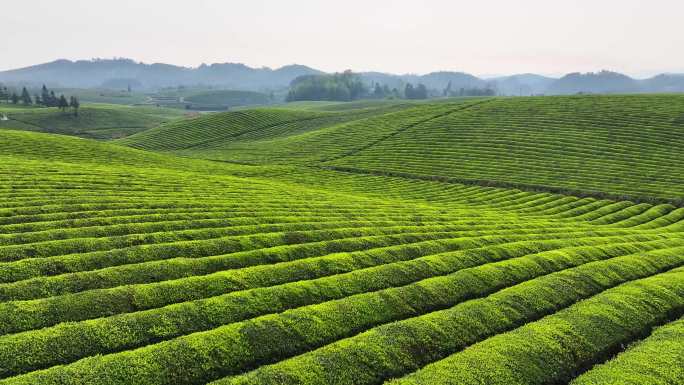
[5,0,684,76]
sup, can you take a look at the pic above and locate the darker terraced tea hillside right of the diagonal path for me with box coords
[328,95,684,202]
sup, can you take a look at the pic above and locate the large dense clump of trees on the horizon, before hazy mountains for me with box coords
[286,71,368,102]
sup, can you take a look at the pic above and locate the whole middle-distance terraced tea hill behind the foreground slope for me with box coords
[120,95,684,204]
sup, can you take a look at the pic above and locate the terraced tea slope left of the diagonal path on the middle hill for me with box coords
[121,99,475,164]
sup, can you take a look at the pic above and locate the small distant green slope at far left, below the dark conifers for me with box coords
[0,104,184,139]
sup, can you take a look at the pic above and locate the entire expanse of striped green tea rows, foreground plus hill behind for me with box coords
[0,95,684,385]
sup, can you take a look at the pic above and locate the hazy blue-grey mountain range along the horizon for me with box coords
[0,59,684,95]
